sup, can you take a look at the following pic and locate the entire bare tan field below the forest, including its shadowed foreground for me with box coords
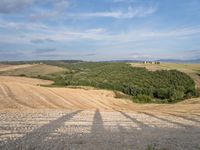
[0,76,200,150]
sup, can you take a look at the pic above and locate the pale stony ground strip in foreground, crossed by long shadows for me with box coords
[0,110,200,150]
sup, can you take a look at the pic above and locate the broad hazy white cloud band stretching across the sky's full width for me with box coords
[0,17,200,45]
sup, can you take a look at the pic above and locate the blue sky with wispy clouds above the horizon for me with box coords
[0,0,200,61]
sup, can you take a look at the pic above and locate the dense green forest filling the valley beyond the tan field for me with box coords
[43,62,196,103]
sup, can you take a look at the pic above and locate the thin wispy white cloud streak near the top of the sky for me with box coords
[30,4,157,21]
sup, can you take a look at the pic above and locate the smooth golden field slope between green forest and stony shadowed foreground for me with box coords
[0,76,200,113]
